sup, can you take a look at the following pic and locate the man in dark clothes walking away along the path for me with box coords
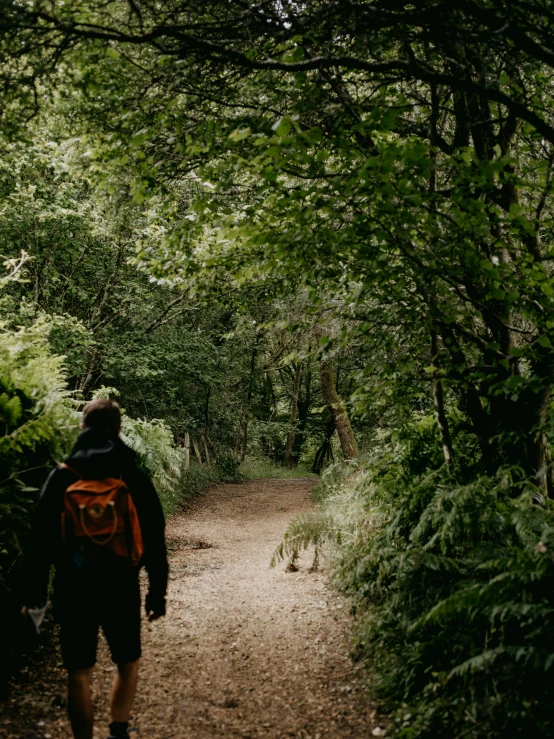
[23,399,168,739]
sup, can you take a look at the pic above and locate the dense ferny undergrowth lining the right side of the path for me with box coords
[275,424,554,739]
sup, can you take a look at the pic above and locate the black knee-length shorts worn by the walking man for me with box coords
[54,567,141,672]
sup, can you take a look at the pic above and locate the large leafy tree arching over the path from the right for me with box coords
[5,2,554,487]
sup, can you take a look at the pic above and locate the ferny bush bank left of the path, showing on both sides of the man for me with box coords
[0,330,196,696]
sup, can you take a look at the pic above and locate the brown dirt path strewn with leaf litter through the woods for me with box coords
[0,480,380,739]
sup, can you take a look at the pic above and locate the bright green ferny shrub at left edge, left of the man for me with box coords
[0,318,78,692]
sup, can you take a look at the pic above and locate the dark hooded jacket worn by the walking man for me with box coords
[22,429,168,615]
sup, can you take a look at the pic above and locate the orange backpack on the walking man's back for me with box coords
[60,464,144,567]
